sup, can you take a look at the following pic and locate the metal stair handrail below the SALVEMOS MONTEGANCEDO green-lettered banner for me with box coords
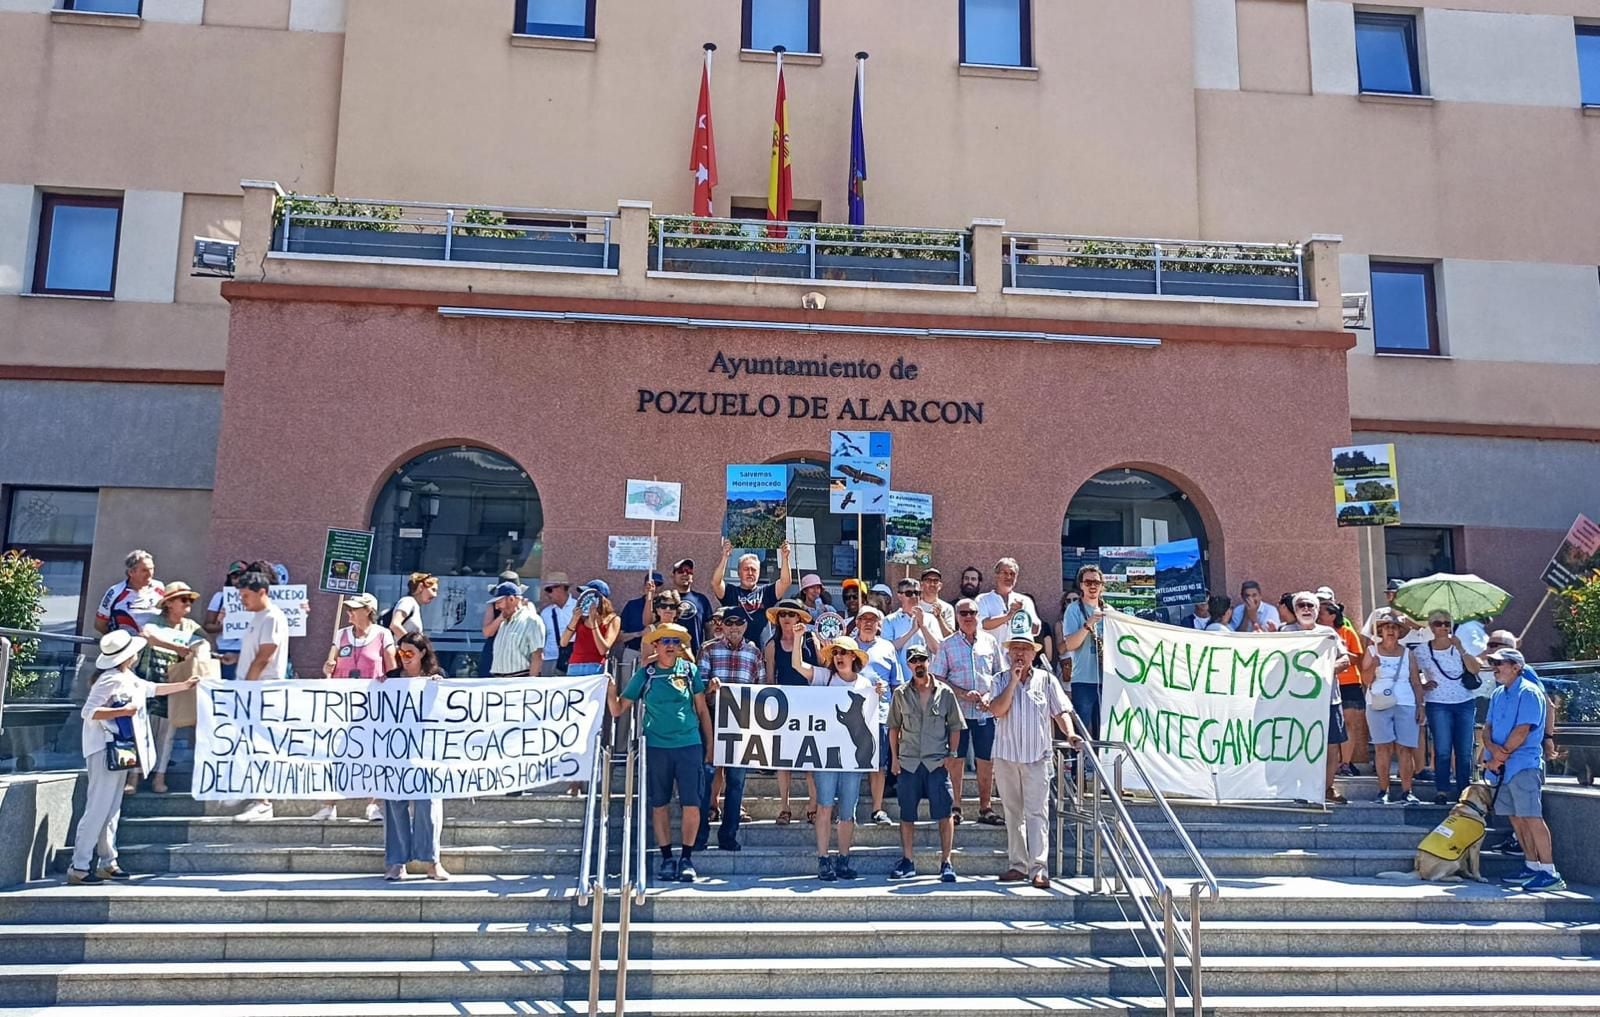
[1056,742,1221,1017]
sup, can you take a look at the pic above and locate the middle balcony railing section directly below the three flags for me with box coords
[650,216,971,286]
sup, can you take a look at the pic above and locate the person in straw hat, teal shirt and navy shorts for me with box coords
[606,625,712,883]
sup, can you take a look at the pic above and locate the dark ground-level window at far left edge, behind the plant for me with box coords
[0,488,99,699]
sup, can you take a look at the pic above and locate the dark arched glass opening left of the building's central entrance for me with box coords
[366,446,544,675]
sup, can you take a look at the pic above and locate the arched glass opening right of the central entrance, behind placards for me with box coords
[1061,467,1210,620]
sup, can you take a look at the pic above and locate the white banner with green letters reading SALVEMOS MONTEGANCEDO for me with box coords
[1101,614,1342,801]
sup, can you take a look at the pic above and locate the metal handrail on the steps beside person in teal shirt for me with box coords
[578,674,650,1017]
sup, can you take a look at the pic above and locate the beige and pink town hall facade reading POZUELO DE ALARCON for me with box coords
[0,0,1600,671]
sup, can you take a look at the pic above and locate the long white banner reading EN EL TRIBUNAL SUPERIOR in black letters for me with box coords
[194,675,606,801]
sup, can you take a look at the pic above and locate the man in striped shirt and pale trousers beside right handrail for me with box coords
[982,635,1082,889]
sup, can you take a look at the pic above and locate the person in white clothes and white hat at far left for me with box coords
[67,628,198,884]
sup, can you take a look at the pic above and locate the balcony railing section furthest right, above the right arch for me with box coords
[1005,233,1306,301]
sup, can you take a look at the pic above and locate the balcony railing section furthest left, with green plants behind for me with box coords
[272,193,618,269]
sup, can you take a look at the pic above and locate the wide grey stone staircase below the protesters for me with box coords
[0,767,1600,1017]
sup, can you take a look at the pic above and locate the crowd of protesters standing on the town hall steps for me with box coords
[69,540,1560,889]
